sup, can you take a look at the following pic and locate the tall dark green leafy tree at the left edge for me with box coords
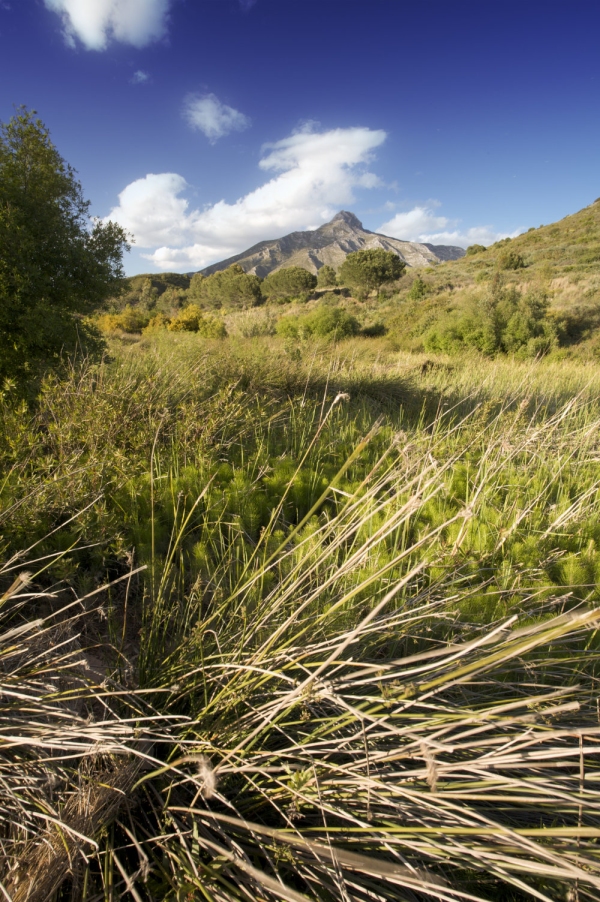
[0,108,128,383]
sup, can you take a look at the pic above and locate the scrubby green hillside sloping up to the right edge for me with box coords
[379,200,600,356]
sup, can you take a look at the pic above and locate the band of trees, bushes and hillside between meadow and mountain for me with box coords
[96,202,600,357]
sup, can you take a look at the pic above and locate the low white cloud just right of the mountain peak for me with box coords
[377,201,519,247]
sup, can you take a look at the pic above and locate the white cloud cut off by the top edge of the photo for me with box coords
[45,0,170,50]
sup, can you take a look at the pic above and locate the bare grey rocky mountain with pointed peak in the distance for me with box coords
[202,210,465,279]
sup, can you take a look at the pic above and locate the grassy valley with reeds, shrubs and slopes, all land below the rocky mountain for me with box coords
[5,177,600,902]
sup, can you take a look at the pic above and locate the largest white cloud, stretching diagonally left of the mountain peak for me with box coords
[107,128,386,270]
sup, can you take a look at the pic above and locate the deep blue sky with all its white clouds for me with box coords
[0,0,600,274]
